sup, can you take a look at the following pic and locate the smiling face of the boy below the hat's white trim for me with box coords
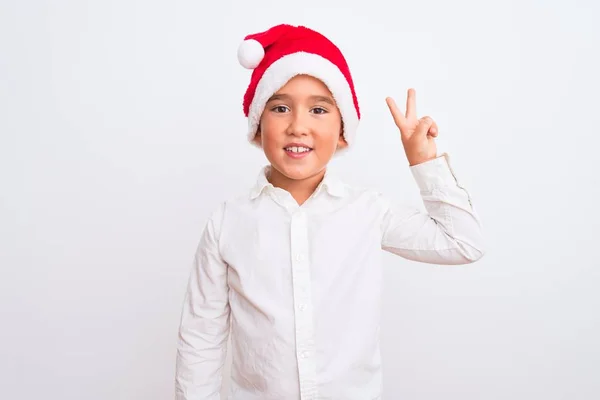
[255,75,347,180]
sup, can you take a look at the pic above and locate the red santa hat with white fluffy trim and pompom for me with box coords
[237,24,360,150]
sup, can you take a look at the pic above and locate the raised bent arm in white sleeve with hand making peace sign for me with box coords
[382,89,483,264]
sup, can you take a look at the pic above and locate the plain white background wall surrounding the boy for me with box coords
[0,0,600,400]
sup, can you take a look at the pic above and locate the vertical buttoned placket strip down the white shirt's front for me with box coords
[291,208,318,400]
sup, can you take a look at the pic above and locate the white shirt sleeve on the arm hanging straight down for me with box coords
[175,207,230,400]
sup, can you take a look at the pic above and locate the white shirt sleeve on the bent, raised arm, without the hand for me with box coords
[382,153,485,265]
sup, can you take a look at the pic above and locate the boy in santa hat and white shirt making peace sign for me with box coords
[176,25,483,400]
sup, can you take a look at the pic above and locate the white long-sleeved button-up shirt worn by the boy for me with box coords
[175,154,484,400]
